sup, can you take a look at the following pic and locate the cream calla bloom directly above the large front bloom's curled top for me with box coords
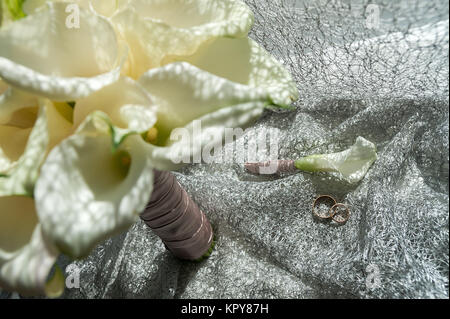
[74,77,156,132]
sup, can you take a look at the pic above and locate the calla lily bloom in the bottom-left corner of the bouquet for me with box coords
[0,196,59,295]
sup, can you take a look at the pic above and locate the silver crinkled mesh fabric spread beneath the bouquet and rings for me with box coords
[2,0,449,298]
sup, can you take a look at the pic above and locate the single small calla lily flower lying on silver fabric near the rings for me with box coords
[295,136,377,183]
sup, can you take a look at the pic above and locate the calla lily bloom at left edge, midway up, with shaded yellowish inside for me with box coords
[0,88,71,196]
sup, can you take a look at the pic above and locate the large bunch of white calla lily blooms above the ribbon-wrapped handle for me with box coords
[0,0,297,296]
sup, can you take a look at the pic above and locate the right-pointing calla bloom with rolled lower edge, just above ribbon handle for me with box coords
[135,62,271,170]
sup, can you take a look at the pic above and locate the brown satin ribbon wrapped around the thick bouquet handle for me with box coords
[140,170,213,260]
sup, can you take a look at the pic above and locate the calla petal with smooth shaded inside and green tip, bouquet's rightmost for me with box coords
[169,38,298,106]
